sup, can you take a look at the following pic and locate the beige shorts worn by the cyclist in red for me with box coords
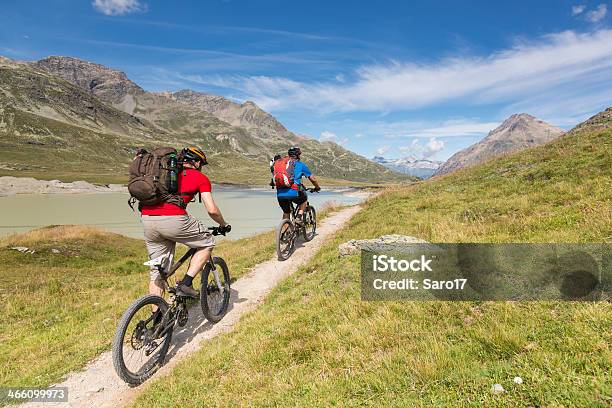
[142,215,215,281]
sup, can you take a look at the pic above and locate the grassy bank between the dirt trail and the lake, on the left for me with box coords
[0,226,274,387]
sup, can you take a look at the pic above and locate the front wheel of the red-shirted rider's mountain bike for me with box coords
[200,256,231,323]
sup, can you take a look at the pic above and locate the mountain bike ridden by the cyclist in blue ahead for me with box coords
[276,188,317,261]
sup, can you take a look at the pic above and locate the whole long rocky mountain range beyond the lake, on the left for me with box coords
[0,57,409,184]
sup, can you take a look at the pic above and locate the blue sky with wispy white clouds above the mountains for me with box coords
[0,0,612,160]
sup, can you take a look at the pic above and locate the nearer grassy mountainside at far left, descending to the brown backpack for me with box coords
[0,59,158,182]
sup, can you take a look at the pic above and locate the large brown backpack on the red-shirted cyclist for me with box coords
[128,147,187,210]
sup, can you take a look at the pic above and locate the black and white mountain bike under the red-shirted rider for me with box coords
[112,227,230,385]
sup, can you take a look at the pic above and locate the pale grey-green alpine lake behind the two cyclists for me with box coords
[0,185,363,239]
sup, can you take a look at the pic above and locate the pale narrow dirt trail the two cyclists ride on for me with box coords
[21,206,361,408]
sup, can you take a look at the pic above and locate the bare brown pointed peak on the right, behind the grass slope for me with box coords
[435,113,564,175]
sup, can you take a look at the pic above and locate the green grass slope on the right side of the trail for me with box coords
[134,120,612,407]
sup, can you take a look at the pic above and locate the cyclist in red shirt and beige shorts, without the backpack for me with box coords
[141,147,231,298]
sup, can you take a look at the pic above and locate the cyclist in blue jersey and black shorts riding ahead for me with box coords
[276,147,321,223]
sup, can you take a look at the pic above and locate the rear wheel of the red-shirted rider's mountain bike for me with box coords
[112,295,172,385]
